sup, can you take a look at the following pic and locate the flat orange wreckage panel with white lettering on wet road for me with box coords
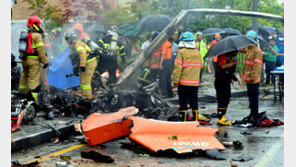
[129,116,225,153]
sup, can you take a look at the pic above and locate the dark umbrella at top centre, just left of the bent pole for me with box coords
[137,14,172,31]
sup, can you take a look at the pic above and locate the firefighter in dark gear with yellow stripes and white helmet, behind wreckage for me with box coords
[98,26,125,88]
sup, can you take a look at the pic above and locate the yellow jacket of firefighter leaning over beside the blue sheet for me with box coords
[71,39,96,67]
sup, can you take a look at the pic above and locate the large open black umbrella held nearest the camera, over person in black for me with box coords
[205,35,257,58]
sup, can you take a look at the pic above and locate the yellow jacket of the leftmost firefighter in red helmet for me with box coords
[27,32,48,64]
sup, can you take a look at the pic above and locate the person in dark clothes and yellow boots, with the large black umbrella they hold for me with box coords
[206,35,256,125]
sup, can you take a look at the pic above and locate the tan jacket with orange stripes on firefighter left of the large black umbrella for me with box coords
[172,48,203,86]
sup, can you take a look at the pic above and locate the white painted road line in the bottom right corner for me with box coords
[255,134,284,167]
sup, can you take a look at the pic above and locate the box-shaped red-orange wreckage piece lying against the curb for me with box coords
[82,107,138,146]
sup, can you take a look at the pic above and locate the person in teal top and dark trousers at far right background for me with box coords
[265,36,279,85]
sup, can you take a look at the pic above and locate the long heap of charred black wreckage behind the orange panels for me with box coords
[11,82,177,125]
